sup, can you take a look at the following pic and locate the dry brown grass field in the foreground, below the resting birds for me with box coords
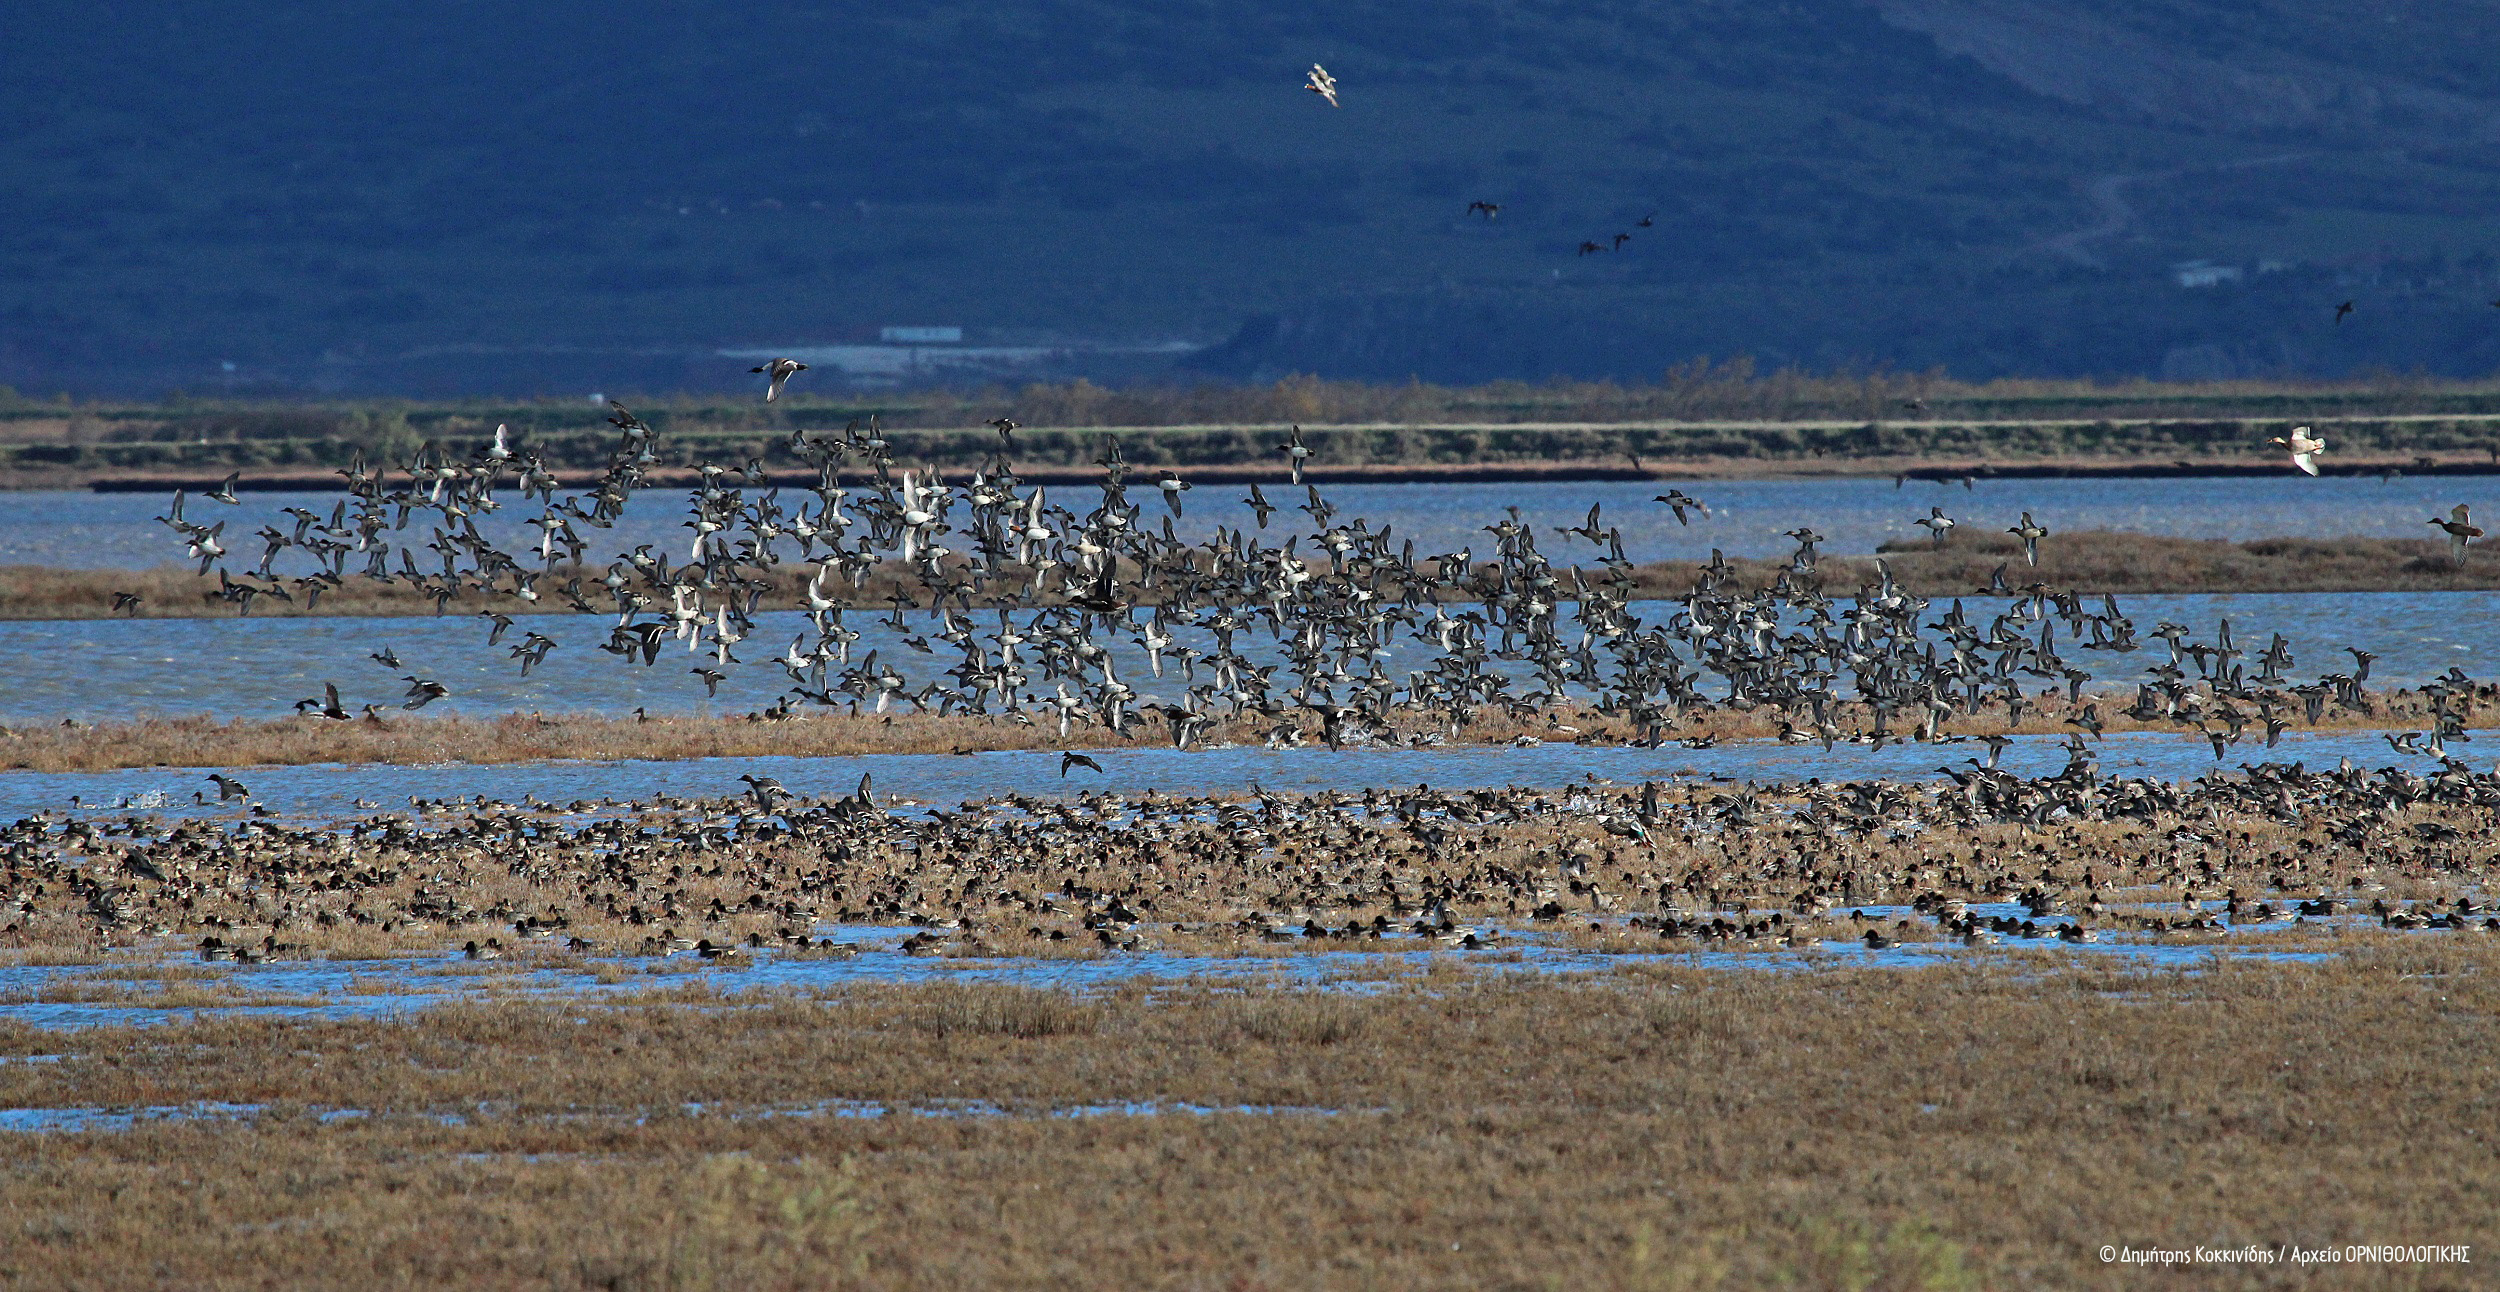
[0,945,2500,1292]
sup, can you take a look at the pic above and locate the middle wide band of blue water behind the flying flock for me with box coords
[0,584,2500,725]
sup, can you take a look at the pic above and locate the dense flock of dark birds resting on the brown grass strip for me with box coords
[0,734,2500,960]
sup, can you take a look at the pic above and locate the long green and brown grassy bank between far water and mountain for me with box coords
[14,367,2500,487]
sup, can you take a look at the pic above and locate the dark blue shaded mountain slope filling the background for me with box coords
[0,0,2500,392]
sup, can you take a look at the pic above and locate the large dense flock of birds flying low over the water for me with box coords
[131,382,2483,775]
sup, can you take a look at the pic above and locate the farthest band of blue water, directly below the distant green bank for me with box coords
[19,472,2500,570]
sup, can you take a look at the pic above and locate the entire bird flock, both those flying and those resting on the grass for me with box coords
[34,55,2500,960]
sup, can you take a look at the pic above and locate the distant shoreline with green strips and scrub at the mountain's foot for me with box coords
[0,397,2500,492]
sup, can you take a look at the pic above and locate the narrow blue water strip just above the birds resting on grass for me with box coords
[0,732,2460,820]
